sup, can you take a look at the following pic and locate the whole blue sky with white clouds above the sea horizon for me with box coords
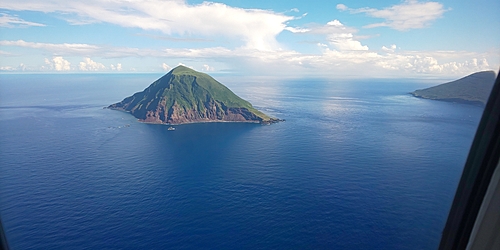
[0,0,500,78]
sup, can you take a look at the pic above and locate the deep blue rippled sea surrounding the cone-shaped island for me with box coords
[0,74,482,250]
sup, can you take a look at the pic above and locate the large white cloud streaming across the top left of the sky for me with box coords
[0,0,294,50]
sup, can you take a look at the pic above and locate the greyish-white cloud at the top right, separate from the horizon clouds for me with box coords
[337,0,446,31]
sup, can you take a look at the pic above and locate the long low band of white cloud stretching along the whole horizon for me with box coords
[0,40,494,77]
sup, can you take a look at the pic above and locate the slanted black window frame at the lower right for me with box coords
[439,71,500,250]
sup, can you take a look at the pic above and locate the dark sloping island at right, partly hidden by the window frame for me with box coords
[410,71,496,106]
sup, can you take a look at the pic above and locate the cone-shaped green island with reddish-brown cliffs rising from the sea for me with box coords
[107,66,283,125]
